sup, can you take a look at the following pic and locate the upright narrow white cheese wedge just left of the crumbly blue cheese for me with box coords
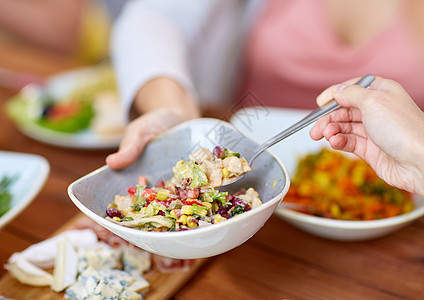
[51,237,78,292]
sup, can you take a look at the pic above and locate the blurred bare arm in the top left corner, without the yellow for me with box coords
[0,0,84,52]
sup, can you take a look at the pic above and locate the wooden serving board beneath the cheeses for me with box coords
[0,213,207,300]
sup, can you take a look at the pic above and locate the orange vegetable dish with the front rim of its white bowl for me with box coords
[276,147,424,241]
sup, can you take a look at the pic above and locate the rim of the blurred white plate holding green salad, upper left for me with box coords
[7,67,122,149]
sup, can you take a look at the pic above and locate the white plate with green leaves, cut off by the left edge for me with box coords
[0,151,50,228]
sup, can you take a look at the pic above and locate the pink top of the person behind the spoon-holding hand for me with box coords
[242,0,424,109]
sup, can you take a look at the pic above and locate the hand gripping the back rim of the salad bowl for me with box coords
[106,78,200,169]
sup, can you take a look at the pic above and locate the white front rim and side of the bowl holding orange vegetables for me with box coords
[275,197,424,241]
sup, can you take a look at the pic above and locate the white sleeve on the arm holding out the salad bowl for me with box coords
[111,0,216,116]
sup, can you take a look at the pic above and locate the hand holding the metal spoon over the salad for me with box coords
[310,78,424,196]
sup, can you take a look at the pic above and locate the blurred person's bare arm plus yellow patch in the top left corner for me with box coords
[0,0,126,63]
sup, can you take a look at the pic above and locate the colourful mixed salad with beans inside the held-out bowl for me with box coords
[106,146,262,231]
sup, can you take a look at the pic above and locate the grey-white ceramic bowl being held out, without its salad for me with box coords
[68,118,290,259]
